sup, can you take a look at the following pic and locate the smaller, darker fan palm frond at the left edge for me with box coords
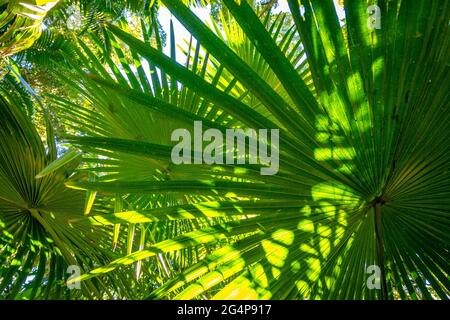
[0,74,135,299]
